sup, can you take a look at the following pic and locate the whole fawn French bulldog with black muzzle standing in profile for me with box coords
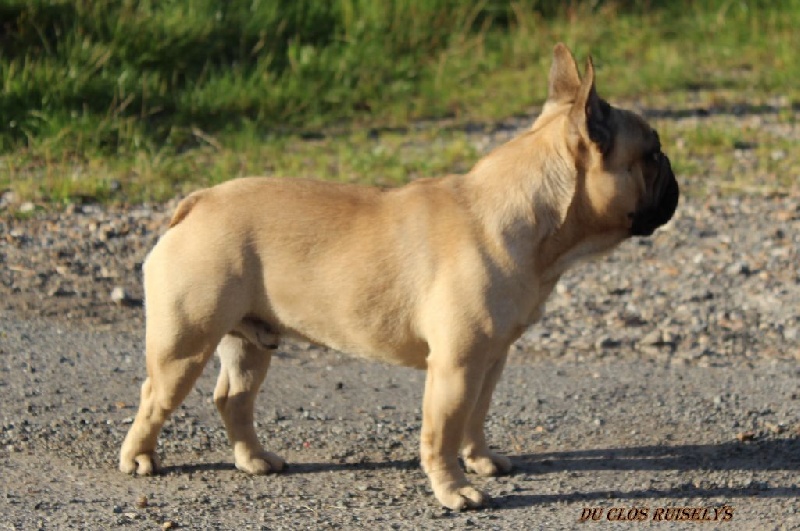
[119,44,679,510]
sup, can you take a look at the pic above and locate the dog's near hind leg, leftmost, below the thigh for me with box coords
[119,328,219,475]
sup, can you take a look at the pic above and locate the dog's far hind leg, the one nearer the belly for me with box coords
[214,334,286,474]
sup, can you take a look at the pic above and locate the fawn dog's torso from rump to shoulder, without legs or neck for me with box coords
[144,178,468,367]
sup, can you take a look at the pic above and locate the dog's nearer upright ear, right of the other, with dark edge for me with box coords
[570,57,614,155]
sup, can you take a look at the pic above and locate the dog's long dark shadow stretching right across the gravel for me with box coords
[159,438,800,509]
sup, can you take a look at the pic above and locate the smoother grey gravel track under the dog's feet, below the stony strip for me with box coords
[0,314,800,529]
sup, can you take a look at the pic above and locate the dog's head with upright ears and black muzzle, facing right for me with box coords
[532,44,679,236]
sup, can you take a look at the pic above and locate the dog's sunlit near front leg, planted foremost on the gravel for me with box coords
[420,358,487,511]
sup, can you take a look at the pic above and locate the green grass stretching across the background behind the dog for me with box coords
[0,0,800,203]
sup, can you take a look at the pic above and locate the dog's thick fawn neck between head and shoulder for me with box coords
[460,128,627,282]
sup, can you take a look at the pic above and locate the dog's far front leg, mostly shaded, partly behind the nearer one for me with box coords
[461,353,511,476]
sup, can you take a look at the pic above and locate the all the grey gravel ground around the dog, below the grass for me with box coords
[0,102,800,529]
